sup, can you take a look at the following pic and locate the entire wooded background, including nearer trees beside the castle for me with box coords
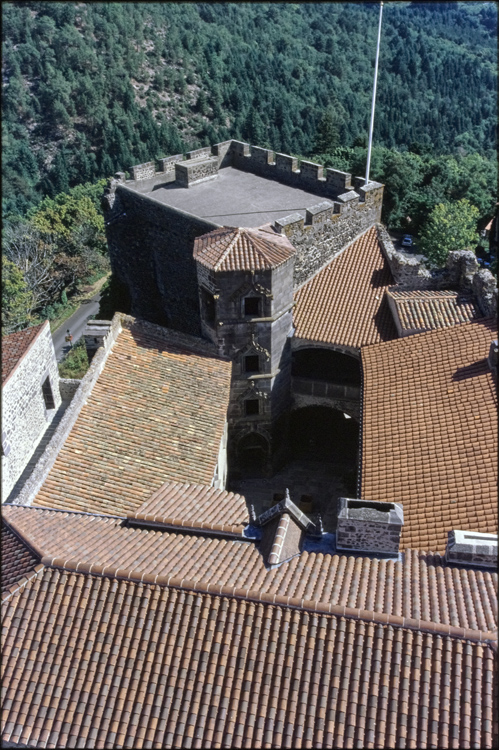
[2,1,497,333]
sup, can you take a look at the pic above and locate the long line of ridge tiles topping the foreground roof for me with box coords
[42,557,497,645]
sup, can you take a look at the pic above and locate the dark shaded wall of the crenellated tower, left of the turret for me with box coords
[105,185,218,336]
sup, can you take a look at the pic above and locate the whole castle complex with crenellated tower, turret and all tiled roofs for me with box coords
[0,142,498,748]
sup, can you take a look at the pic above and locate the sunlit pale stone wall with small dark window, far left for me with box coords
[2,322,61,501]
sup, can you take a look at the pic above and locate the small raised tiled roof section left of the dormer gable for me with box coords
[128,482,250,535]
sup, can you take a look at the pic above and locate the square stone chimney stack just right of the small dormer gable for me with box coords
[336,497,404,555]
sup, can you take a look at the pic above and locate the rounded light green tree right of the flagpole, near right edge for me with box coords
[419,198,479,266]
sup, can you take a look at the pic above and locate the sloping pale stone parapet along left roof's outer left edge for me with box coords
[14,313,123,505]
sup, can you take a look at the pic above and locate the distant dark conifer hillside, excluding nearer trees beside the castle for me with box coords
[2,2,497,214]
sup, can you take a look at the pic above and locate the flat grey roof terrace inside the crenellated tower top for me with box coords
[126,167,331,227]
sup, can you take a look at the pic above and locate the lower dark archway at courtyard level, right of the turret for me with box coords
[289,406,359,469]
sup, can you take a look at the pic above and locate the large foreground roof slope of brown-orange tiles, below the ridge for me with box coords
[2,568,497,748]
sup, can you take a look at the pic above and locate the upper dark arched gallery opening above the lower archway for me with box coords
[291,347,361,387]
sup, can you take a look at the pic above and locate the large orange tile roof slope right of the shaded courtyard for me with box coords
[361,319,497,552]
